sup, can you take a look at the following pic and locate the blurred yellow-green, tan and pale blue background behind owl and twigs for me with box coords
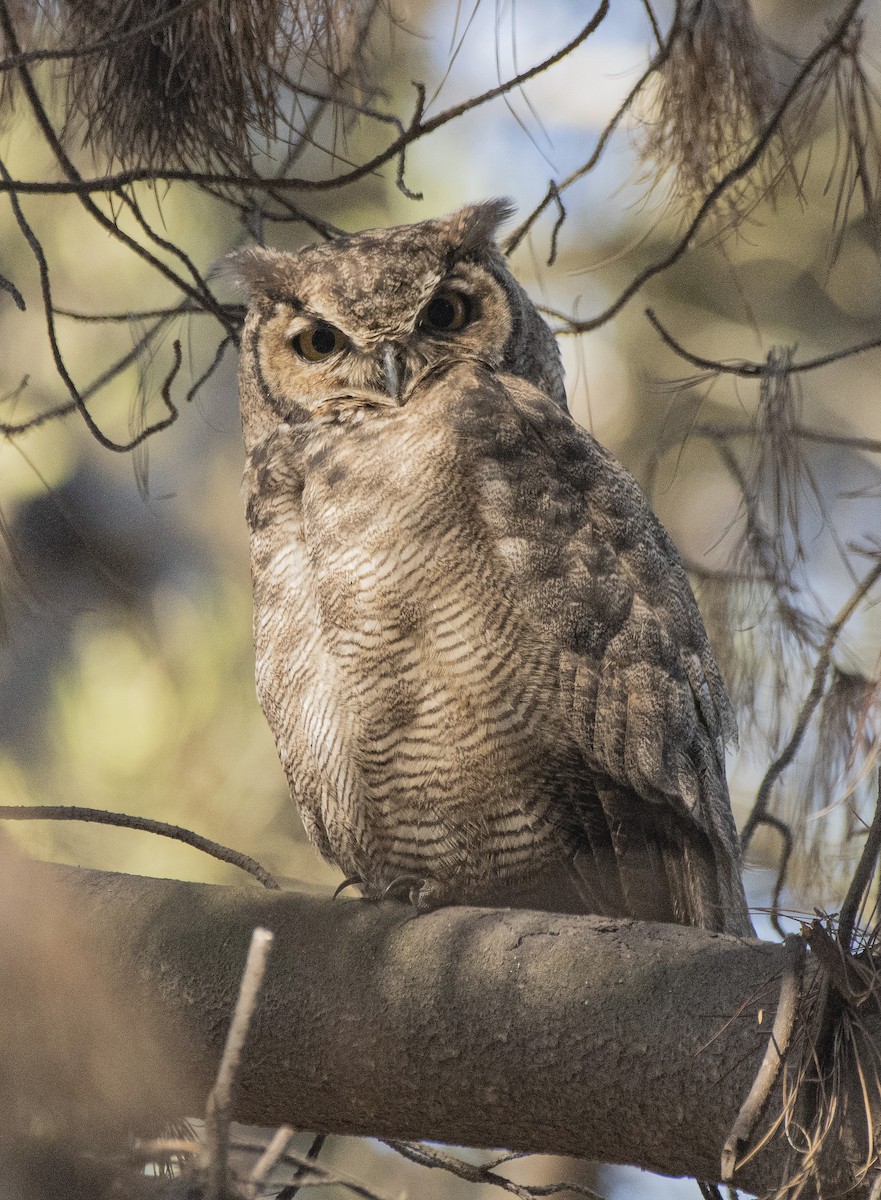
[0,0,881,1196]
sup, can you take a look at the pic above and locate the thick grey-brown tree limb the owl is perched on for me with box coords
[32,868,881,1192]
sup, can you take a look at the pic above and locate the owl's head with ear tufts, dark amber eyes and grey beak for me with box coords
[230,200,565,444]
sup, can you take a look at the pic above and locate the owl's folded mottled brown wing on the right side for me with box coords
[470,377,751,934]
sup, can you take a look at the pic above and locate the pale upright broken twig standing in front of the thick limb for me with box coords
[204,928,274,1200]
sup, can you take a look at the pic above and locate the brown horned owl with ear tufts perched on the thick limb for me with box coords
[233,200,751,934]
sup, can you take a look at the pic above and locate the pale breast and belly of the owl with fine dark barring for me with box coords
[252,388,585,882]
